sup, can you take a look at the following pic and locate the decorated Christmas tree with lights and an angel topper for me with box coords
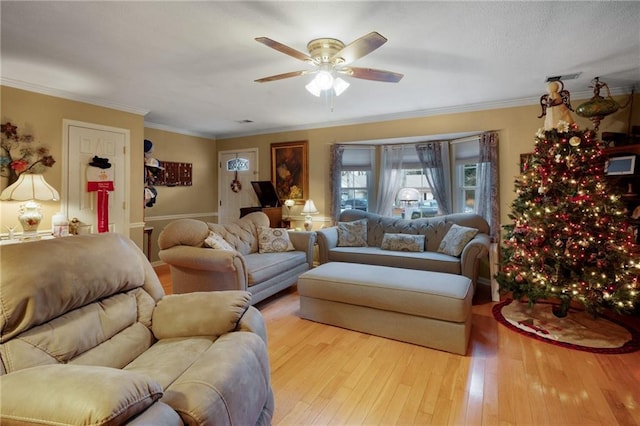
[496,82,640,317]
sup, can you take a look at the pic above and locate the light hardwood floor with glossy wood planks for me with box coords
[156,266,640,425]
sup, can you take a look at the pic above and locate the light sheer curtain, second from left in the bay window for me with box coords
[374,145,404,216]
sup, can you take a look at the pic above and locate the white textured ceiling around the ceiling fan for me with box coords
[0,0,640,138]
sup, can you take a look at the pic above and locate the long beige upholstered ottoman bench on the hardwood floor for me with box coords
[298,262,473,355]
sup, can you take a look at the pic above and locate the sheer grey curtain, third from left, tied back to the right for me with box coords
[416,141,452,214]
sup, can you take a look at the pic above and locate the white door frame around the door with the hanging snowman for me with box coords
[60,118,131,237]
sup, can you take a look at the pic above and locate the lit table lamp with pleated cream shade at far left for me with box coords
[0,173,60,239]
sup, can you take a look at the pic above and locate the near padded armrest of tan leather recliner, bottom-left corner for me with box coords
[0,364,162,425]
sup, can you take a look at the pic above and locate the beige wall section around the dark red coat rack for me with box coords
[144,127,218,262]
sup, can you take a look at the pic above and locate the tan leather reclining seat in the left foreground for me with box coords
[0,233,274,426]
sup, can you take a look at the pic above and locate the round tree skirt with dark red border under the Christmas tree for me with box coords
[493,299,640,354]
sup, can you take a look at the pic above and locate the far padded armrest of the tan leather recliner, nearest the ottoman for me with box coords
[151,291,251,339]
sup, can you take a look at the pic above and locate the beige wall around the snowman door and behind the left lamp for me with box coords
[0,86,144,246]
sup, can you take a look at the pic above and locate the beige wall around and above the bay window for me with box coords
[216,95,640,230]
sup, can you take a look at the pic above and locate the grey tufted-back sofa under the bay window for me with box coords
[317,209,490,288]
